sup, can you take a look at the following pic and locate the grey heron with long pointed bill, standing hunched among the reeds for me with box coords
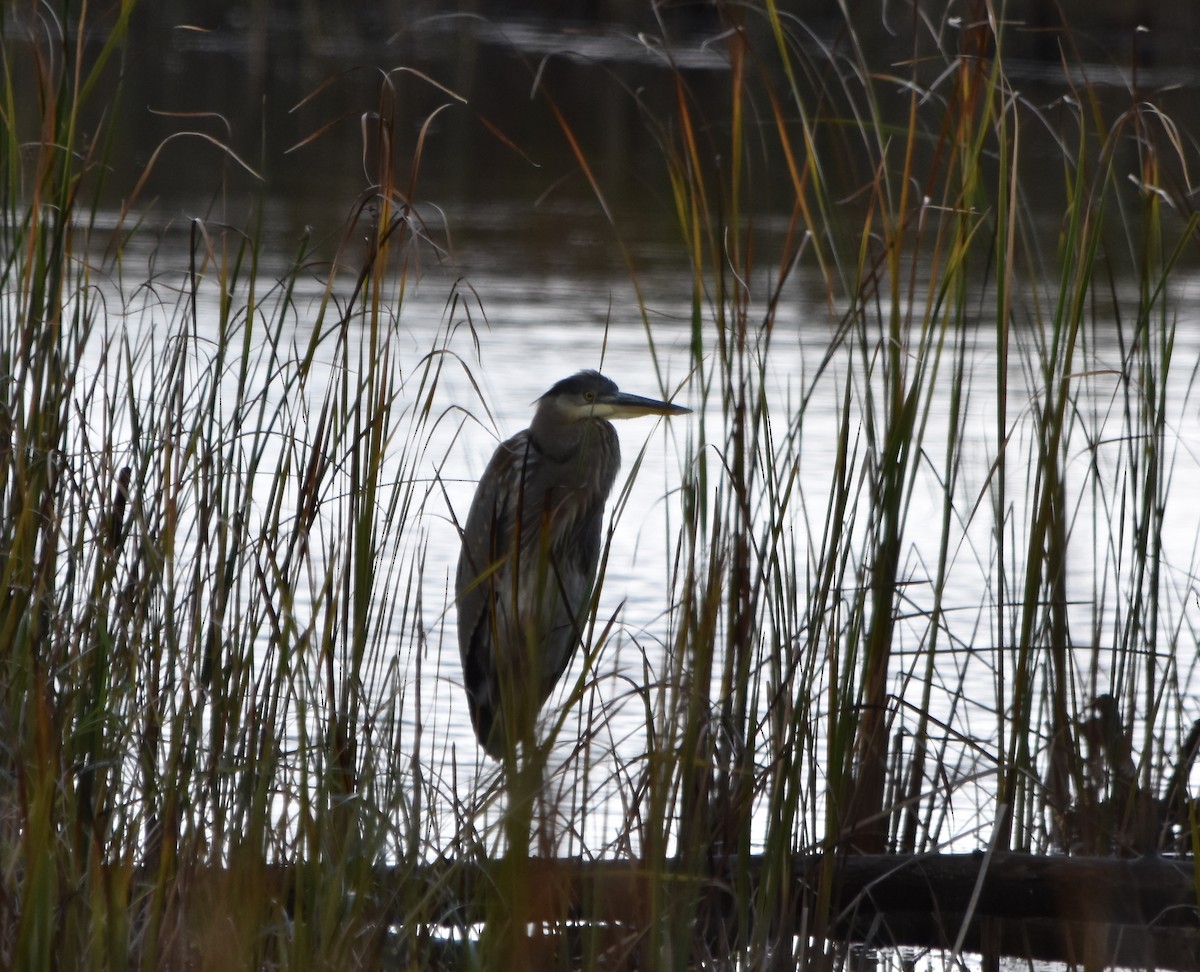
[457,371,691,760]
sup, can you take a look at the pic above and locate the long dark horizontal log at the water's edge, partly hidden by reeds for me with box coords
[142,852,1200,970]
